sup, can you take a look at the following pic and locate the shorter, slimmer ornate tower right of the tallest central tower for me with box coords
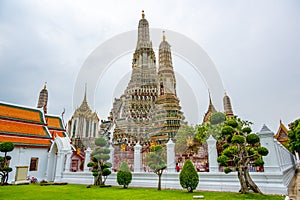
[150,34,184,143]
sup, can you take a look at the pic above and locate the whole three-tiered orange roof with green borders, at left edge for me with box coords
[0,102,52,148]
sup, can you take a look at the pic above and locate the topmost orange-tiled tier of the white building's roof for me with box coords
[0,102,45,124]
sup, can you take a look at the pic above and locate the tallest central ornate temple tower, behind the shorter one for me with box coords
[110,11,157,143]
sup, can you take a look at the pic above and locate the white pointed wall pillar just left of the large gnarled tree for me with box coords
[206,135,219,172]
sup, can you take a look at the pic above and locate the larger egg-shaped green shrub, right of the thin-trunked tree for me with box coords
[179,159,199,192]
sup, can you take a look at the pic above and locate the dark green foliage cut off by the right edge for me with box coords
[288,119,300,153]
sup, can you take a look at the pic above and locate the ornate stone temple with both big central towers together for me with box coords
[100,12,184,145]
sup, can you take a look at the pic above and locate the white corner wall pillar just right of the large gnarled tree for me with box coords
[258,125,280,172]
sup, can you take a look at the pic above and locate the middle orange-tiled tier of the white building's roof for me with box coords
[0,119,51,138]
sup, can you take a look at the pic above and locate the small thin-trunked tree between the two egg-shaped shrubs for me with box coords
[146,145,167,190]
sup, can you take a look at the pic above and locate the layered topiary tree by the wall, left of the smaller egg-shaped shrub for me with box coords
[86,138,112,186]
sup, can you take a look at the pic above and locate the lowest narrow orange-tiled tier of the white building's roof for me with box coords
[0,133,51,147]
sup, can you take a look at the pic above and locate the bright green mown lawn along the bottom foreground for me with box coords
[0,184,284,200]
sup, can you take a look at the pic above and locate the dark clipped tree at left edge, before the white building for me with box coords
[0,142,15,185]
